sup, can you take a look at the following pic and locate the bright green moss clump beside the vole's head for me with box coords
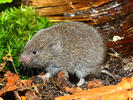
[0,6,52,72]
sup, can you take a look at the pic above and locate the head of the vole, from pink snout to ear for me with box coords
[19,29,62,67]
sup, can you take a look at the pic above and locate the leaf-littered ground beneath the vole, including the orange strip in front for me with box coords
[0,56,133,100]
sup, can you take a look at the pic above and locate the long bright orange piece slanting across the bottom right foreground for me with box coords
[55,76,133,100]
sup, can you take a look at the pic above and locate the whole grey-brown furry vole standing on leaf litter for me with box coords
[20,22,107,86]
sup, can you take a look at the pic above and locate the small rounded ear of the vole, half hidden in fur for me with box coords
[50,38,62,51]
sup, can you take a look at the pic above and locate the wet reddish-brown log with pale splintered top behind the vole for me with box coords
[25,0,133,55]
